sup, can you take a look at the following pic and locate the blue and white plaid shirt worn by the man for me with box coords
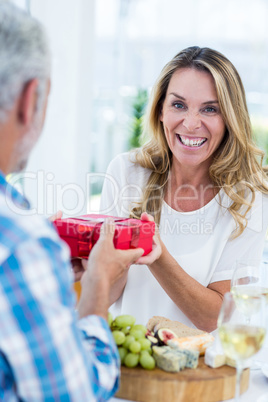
[0,173,119,402]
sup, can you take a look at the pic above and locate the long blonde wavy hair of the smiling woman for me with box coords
[130,46,268,238]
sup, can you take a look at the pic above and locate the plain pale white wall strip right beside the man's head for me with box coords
[24,0,95,215]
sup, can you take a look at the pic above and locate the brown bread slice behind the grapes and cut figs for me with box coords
[147,316,207,338]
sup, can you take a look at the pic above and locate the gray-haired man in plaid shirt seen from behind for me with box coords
[0,0,149,402]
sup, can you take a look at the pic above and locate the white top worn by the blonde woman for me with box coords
[100,153,268,327]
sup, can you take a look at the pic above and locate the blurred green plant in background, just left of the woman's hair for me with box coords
[129,89,148,148]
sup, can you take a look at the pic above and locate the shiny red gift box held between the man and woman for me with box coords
[53,214,155,258]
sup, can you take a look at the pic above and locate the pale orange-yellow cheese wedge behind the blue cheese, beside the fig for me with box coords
[167,333,214,355]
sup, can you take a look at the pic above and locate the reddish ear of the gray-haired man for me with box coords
[17,79,38,126]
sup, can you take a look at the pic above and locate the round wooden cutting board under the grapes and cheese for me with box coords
[116,357,249,402]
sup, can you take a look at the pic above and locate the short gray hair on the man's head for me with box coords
[0,0,50,122]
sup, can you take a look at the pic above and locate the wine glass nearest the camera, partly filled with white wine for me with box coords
[218,292,266,402]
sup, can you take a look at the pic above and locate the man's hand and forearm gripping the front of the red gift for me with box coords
[78,219,144,318]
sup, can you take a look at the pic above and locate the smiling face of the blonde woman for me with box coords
[160,68,225,169]
